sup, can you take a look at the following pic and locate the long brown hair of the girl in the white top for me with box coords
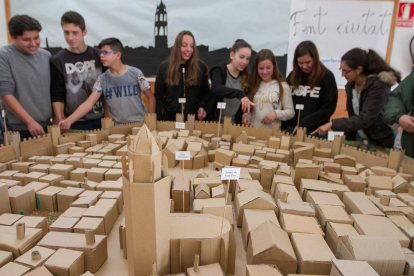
[247,49,286,102]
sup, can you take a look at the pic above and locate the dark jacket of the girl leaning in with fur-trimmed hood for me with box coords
[332,72,395,148]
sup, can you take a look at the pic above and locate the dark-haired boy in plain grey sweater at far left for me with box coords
[0,15,52,140]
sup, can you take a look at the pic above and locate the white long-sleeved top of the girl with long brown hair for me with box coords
[250,80,295,128]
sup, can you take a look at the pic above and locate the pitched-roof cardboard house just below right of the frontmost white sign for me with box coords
[235,188,278,227]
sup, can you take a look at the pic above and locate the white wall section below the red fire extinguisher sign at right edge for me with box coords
[390,0,414,78]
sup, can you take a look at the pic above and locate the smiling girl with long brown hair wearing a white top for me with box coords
[243,49,295,128]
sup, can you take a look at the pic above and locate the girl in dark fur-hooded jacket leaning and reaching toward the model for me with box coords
[314,48,401,148]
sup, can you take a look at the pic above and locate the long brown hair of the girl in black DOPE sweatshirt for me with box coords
[290,40,326,89]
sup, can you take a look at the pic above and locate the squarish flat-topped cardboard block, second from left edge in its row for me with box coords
[9,186,36,215]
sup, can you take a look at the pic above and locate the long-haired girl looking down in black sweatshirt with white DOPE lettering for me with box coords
[283,41,338,138]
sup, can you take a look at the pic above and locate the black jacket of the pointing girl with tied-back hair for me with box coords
[210,63,246,124]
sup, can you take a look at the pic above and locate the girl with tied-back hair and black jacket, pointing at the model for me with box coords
[210,39,255,124]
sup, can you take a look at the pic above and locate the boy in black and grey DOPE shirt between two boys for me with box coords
[50,11,104,130]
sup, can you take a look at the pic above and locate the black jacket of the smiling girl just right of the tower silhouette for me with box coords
[154,60,210,121]
